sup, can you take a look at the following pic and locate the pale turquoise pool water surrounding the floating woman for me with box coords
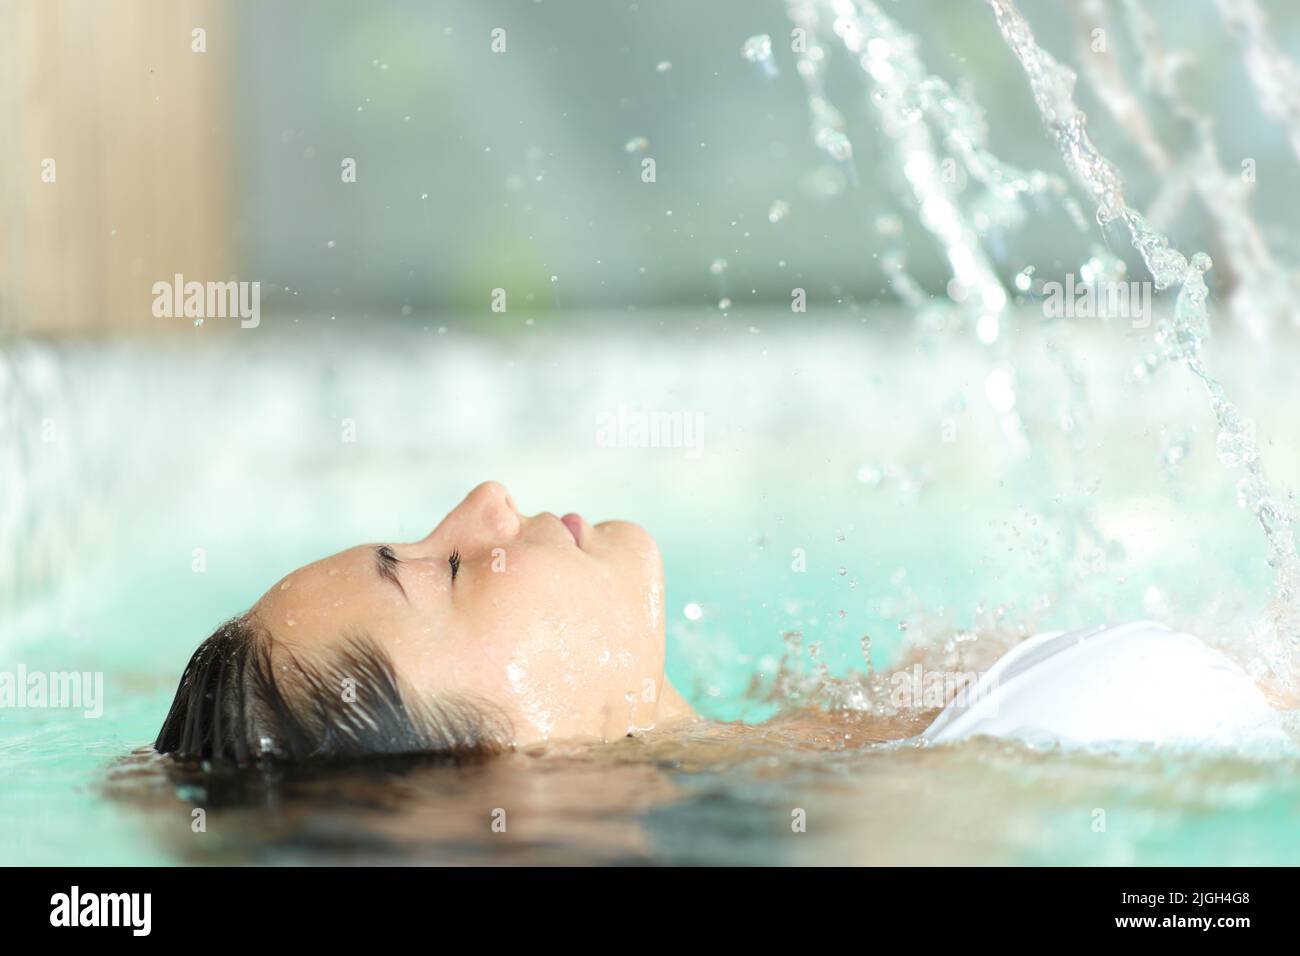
[0,312,1300,864]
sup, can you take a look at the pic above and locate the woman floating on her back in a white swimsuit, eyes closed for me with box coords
[155,481,1284,765]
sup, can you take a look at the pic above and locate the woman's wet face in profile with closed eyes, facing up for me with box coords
[250,481,666,745]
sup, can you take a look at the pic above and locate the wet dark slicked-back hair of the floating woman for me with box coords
[153,617,510,766]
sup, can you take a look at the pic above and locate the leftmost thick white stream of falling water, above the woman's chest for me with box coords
[769,0,1126,616]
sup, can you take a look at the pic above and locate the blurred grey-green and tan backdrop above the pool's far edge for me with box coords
[0,0,1300,333]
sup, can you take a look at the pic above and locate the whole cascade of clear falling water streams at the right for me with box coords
[764,0,1300,697]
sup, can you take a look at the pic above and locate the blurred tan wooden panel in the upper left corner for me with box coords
[0,0,234,333]
